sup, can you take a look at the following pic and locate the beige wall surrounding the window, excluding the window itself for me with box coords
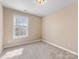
[4,8,42,47]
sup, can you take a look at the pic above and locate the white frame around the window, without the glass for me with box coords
[13,14,29,39]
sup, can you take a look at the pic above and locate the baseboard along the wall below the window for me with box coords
[4,39,41,48]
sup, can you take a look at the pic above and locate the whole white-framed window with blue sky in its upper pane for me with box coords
[13,15,28,38]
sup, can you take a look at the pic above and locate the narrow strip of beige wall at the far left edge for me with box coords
[0,3,3,53]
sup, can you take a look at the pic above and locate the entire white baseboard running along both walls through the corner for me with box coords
[4,39,78,56]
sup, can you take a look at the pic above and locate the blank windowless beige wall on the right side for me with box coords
[43,3,78,53]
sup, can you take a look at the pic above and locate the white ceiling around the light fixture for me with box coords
[2,0,77,16]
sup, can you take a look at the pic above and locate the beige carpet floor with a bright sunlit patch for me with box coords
[0,42,78,59]
